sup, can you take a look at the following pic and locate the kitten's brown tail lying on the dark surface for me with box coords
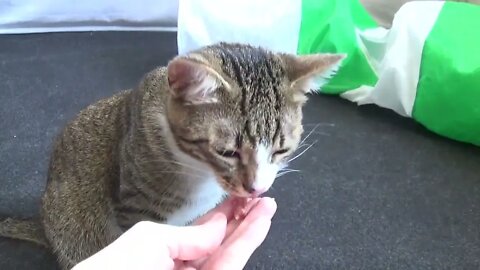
[0,218,49,248]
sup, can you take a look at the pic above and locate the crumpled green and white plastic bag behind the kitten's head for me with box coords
[178,0,480,146]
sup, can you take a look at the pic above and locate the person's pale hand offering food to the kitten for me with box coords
[73,198,277,270]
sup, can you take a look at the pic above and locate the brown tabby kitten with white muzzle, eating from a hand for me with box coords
[0,43,344,269]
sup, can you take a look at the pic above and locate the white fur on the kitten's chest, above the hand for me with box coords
[160,115,226,226]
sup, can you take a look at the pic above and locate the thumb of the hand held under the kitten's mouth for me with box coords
[165,214,227,260]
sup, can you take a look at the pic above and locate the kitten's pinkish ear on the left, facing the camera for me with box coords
[167,57,225,104]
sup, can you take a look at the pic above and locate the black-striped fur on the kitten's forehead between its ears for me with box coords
[207,45,284,144]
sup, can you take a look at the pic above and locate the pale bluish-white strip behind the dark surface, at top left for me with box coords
[0,0,178,34]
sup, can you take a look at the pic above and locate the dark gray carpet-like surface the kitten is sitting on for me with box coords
[0,32,480,270]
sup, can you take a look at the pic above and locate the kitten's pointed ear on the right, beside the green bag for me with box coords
[280,54,347,98]
